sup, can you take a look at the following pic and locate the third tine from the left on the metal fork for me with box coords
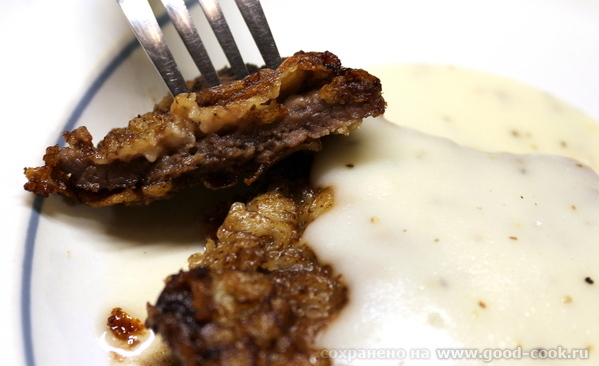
[199,0,249,79]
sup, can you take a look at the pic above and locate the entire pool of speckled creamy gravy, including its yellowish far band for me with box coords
[304,65,599,366]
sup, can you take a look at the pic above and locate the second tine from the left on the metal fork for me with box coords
[162,0,220,86]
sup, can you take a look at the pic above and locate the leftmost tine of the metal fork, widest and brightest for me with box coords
[117,0,189,96]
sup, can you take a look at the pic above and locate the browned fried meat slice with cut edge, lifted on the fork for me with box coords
[25,52,385,206]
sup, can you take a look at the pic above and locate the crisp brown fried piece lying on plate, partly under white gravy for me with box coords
[146,183,347,366]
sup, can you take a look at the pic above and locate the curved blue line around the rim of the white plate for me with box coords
[20,5,180,366]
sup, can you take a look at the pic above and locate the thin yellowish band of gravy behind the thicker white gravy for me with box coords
[368,64,599,171]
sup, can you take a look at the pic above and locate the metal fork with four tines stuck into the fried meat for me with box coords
[117,0,281,96]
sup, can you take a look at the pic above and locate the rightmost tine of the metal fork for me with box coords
[235,0,281,69]
